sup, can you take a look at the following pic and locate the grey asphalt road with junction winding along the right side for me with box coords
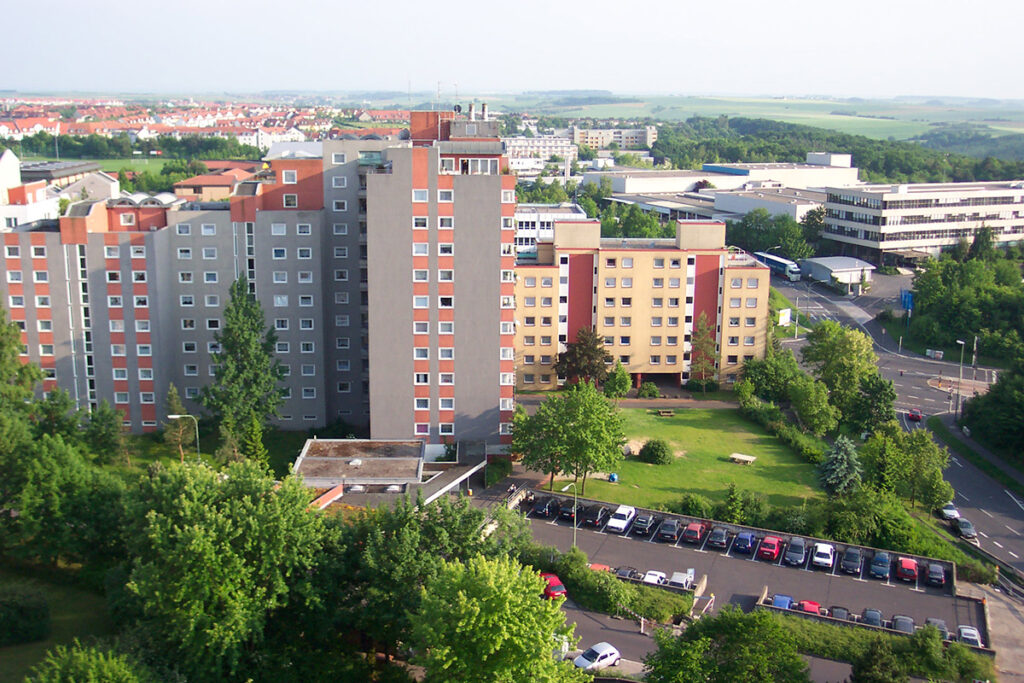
[772,276,1024,571]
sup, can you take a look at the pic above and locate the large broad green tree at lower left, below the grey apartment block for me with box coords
[128,462,323,680]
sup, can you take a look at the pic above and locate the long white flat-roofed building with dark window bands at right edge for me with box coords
[821,180,1024,263]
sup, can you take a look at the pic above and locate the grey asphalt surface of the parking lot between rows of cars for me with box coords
[529,494,988,644]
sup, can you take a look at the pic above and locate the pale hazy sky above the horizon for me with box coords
[6,0,1024,99]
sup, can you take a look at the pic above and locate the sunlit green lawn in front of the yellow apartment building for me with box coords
[586,409,820,508]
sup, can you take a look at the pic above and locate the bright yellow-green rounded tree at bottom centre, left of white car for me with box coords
[411,556,590,683]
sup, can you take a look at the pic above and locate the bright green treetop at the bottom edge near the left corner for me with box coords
[25,639,160,683]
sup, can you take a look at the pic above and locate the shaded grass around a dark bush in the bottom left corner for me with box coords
[0,567,114,683]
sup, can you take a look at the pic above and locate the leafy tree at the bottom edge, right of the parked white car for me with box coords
[644,605,810,683]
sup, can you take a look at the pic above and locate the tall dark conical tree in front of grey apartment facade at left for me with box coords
[202,275,283,440]
